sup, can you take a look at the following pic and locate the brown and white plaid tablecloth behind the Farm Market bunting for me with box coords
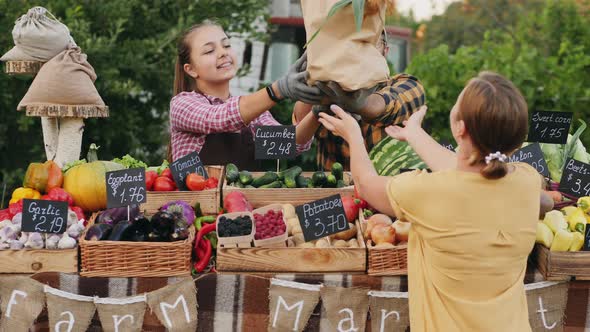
[6,265,590,331]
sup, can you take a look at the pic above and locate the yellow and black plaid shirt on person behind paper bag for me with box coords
[293,74,426,170]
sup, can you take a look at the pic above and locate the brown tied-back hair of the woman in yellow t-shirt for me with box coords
[458,72,528,179]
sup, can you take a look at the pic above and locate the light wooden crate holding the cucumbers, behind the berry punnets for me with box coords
[221,172,354,209]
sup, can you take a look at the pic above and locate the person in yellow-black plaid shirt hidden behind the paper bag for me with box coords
[292,30,426,170]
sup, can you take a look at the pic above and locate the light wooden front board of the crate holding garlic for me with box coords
[0,248,78,273]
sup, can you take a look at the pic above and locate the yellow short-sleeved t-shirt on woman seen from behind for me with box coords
[387,163,541,332]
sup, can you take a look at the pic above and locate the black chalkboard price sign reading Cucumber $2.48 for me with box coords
[254,126,296,159]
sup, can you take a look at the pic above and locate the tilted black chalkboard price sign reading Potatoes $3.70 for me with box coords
[295,195,354,242]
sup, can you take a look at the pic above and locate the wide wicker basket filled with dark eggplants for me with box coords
[80,213,195,277]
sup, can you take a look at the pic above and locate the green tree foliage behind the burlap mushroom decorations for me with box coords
[0,0,268,206]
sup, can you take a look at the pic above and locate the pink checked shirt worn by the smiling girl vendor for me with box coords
[170,91,313,160]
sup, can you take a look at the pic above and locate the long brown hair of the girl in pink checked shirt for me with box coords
[171,19,227,162]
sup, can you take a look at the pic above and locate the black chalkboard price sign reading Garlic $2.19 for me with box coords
[22,199,68,234]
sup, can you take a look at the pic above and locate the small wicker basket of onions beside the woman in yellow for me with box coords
[359,211,408,276]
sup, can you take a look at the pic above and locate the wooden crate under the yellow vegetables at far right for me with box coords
[531,244,590,281]
